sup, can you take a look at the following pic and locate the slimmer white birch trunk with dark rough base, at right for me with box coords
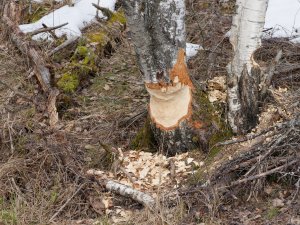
[227,0,268,134]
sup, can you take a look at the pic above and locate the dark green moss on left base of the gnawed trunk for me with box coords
[131,118,155,151]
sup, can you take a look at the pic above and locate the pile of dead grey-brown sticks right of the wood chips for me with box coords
[210,115,300,187]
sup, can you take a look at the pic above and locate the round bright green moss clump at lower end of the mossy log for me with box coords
[57,73,79,93]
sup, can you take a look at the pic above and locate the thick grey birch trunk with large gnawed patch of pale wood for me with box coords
[123,0,193,155]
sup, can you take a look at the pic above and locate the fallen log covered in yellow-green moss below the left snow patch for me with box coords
[53,11,126,93]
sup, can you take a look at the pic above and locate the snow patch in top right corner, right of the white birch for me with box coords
[265,0,300,42]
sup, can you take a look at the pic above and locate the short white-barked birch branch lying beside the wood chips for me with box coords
[87,170,155,208]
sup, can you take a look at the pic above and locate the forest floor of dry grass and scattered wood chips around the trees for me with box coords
[0,0,300,225]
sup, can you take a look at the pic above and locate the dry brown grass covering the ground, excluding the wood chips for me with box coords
[0,0,299,225]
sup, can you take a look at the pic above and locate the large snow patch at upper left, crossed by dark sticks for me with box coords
[20,0,116,40]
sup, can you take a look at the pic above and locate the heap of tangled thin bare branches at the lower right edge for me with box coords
[210,114,300,194]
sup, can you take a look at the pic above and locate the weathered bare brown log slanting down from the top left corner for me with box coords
[0,2,50,92]
